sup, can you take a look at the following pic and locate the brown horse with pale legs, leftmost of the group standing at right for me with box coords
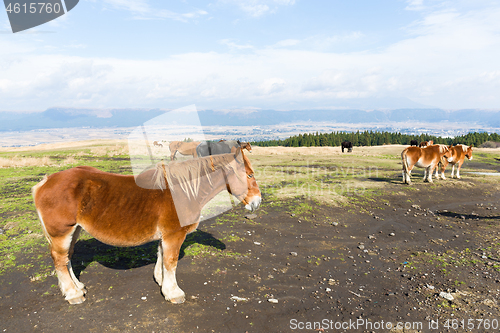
[401,145,450,185]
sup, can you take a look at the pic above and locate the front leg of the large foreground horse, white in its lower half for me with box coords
[161,229,186,304]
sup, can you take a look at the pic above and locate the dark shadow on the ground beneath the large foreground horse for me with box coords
[71,230,226,278]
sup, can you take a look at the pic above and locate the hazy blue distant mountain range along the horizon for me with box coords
[0,108,500,131]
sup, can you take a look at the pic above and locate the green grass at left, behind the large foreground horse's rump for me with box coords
[0,143,131,274]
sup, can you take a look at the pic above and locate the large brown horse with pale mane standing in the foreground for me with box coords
[33,150,261,304]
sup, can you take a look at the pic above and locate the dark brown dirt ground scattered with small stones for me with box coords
[0,147,500,332]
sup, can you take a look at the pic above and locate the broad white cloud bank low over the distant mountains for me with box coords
[0,1,500,110]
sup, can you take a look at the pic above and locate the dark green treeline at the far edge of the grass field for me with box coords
[251,131,500,147]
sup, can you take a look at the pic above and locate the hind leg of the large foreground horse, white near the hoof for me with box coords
[49,225,85,304]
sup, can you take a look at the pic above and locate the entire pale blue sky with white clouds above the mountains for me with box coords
[0,0,500,111]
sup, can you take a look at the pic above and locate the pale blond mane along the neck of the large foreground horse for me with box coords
[153,154,240,198]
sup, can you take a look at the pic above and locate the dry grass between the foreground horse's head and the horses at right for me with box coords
[248,145,406,205]
